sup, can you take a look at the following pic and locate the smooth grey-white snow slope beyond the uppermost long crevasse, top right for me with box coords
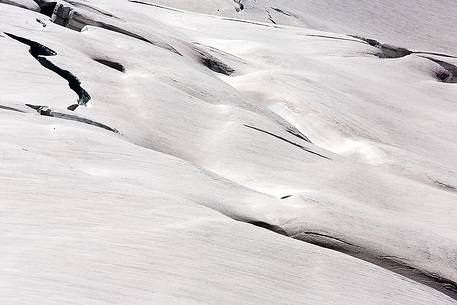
[146,0,457,55]
